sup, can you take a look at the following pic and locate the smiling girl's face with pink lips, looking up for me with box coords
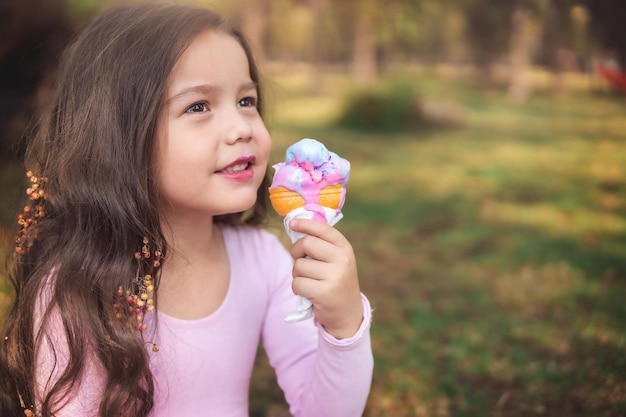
[155,31,271,221]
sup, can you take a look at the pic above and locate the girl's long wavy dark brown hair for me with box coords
[0,3,268,417]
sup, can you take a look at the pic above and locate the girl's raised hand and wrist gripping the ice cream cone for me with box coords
[289,219,363,339]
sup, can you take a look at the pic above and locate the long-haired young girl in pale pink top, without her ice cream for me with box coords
[0,4,373,417]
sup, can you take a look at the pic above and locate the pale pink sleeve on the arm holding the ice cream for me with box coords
[263,231,374,417]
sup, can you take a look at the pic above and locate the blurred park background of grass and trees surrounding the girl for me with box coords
[0,0,626,417]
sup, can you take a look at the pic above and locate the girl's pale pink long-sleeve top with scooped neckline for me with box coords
[37,227,373,417]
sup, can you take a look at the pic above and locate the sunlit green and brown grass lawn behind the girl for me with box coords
[0,66,626,417]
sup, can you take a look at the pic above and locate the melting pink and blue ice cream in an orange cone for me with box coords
[269,138,350,222]
